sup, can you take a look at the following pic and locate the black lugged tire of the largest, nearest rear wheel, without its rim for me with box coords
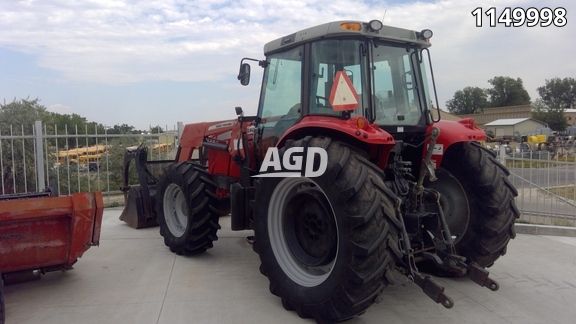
[254,136,398,323]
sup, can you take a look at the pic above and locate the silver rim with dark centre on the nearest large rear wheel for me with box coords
[268,178,339,287]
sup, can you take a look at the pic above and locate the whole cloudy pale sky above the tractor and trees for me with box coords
[0,0,576,129]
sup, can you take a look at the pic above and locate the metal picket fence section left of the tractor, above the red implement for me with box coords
[0,121,181,194]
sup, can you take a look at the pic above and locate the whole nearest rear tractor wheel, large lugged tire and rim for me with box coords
[254,137,400,322]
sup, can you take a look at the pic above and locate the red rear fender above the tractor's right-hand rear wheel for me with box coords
[426,118,486,166]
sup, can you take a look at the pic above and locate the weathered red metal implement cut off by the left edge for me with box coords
[0,192,103,274]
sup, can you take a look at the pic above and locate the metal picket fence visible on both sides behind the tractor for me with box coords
[0,122,576,219]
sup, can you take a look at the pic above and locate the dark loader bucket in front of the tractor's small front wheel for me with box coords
[120,145,174,229]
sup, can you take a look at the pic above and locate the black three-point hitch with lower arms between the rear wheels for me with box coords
[396,128,499,308]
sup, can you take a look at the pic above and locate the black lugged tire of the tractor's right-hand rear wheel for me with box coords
[442,142,520,267]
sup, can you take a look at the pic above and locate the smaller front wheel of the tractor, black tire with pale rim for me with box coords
[156,162,220,255]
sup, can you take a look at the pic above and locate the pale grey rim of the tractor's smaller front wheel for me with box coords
[163,183,188,237]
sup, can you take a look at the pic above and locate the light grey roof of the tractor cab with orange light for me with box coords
[264,20,430,55]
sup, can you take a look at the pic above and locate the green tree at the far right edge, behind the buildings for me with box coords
[538,78,576,109]
